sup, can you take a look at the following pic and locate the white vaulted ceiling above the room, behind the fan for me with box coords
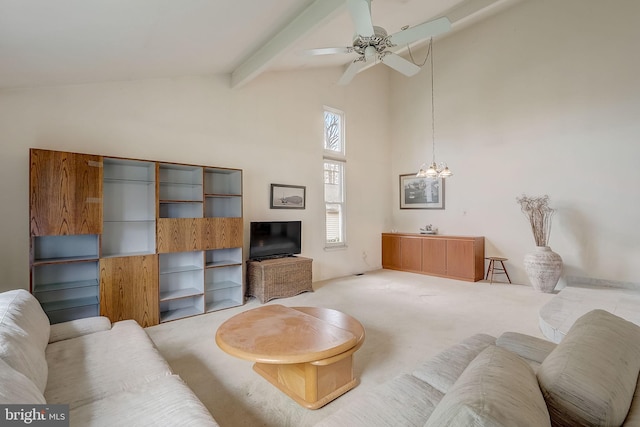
[0,0,518,88]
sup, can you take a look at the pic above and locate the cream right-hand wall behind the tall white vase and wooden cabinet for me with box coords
[389,0,640,286]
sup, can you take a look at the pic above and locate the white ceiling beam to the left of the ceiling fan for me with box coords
[231,0,346,88]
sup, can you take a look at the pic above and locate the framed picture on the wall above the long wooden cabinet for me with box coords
[400,173,444,209]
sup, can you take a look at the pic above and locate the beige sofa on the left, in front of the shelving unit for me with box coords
[0,290,218,427]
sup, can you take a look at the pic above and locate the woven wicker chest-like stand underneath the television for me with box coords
[247,256,313,304]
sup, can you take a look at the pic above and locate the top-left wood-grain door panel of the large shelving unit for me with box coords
[29,149,102,236]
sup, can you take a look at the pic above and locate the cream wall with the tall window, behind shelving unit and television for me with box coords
[0,67,391,290]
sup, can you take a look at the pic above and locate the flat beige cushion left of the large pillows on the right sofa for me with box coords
[413,334,496,393]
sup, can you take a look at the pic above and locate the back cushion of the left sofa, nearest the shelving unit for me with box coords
[0,289,50,392]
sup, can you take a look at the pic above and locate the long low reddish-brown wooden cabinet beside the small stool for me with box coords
[382,233,484,282]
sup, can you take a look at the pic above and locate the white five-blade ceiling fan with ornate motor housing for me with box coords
[304,0,451,85]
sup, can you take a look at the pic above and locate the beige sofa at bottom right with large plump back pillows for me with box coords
[318,310,640,427]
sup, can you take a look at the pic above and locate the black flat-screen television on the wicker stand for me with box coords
[249,221,302,260]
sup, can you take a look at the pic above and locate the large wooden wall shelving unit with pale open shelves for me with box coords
[30,149,244,326]
